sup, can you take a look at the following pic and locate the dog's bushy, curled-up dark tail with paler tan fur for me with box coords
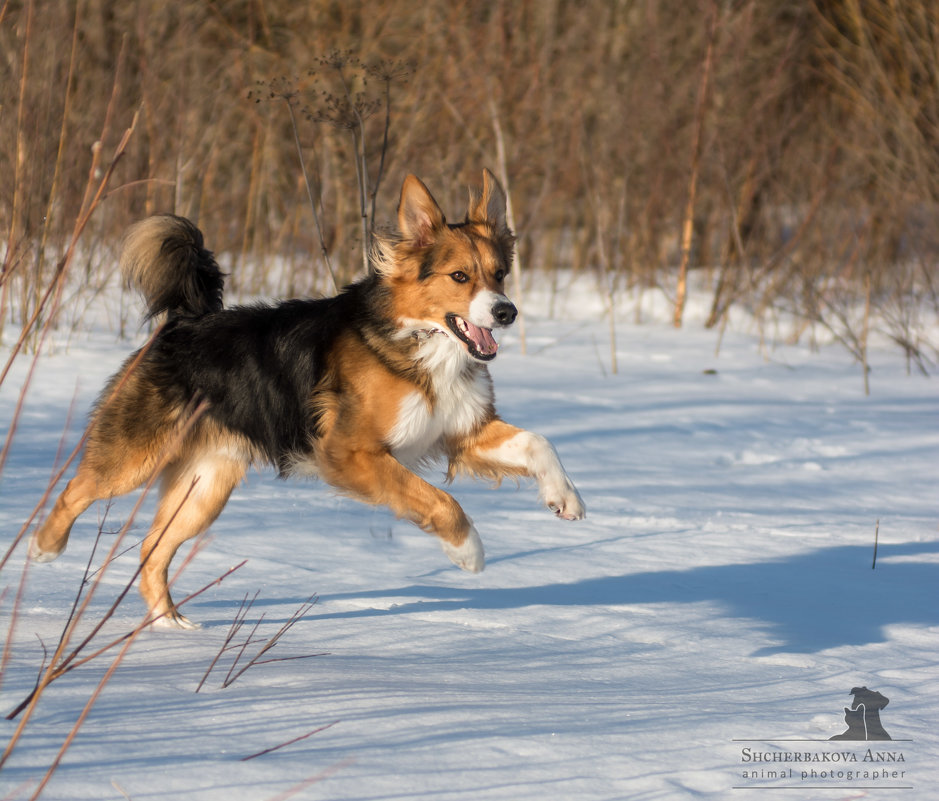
[121,214,225,318]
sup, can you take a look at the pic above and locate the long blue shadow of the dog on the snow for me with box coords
[310,542,939,656]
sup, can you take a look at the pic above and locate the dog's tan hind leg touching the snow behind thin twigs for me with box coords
[140,453,247,629]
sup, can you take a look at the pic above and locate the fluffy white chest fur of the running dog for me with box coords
[387,340,493,467]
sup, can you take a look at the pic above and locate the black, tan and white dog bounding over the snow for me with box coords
[30,170,584,628]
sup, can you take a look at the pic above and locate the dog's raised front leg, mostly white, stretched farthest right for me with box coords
[450,418,586,520]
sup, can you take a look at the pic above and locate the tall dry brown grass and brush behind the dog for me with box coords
[0,0,939,366]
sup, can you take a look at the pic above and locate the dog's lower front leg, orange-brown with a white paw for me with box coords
[319,448,486,573]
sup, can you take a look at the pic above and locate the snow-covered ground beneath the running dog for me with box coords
[0,278,939,801]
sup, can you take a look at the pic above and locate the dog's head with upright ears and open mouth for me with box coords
[375,170,518,361]
